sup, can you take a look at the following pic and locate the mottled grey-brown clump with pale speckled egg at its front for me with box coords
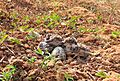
[38,34,89,60]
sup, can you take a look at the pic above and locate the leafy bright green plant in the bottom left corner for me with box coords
[0,65,16,81]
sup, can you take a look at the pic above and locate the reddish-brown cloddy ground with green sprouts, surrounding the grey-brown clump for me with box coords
[0,0,120,81]
